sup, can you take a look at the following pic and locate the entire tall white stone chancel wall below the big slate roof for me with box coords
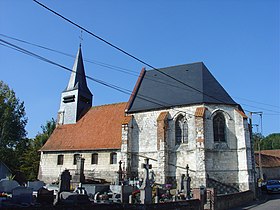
[128,105,251,190]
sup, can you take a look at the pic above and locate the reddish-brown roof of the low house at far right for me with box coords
[255,150,280,168]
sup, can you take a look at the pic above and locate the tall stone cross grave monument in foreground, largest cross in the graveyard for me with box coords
[140,158,152,204]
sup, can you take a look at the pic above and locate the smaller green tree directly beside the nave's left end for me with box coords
[20,119,56,181]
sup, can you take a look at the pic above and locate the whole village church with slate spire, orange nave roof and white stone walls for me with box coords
[38,47,254,193]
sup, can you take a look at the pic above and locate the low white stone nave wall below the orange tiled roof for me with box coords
[38,150,122,183]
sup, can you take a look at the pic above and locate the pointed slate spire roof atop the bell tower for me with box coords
[64,46,92,95]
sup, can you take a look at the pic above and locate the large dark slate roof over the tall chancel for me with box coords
[127,62,237,113]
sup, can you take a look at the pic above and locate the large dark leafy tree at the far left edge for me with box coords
[0,81,28,171]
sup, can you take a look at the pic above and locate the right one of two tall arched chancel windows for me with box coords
[213,113,226,142]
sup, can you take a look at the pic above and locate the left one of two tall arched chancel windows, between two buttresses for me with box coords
[175,115,188,145]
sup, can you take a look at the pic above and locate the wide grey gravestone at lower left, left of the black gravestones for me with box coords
[12,186,33,204]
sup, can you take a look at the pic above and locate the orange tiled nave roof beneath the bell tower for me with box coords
[41,103,128,151]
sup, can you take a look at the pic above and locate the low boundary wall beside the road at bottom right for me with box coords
[215,191,254,210]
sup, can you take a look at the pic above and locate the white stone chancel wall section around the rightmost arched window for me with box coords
[205,105,253,191]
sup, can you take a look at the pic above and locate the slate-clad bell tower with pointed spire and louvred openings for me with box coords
[57,45,92,125]
